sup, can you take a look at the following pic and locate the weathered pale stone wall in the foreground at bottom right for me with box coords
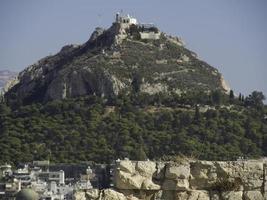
[75,160,267,200]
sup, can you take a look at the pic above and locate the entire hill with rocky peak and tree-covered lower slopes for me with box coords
[0,13,267,164]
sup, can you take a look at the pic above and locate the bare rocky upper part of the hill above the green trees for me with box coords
[3,14,229,104]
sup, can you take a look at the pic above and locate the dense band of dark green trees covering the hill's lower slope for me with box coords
[0,90,267,164]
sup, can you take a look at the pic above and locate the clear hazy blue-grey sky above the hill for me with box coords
[0,0,267,98]
